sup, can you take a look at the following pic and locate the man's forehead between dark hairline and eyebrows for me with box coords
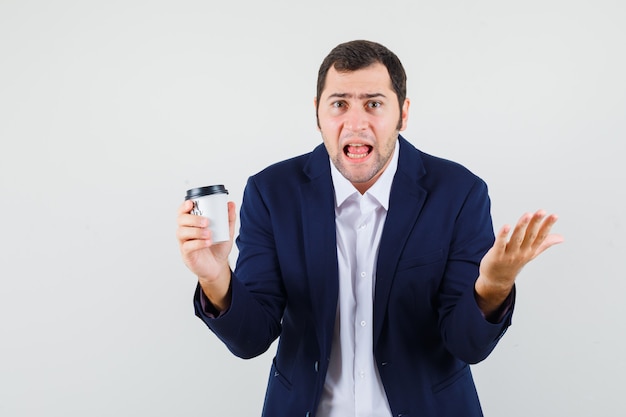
[322,62,395,97]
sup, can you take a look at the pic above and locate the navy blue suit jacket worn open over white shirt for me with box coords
[195,137,513,417]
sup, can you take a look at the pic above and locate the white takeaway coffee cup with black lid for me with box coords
[185,185,230,243]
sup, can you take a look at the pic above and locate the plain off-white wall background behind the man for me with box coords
[0,0,626,417]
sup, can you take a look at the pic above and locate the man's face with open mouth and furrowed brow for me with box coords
[316,63,409,193]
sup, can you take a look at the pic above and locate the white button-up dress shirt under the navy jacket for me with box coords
[317,142,400,417]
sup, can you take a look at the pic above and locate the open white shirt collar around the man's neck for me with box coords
[330,140,400,210]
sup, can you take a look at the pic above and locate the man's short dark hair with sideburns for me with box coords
[315,40,406,128]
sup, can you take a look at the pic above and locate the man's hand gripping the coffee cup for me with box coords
[176,200,236,311]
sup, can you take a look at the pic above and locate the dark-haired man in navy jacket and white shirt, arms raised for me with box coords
[177,41,562,417]
